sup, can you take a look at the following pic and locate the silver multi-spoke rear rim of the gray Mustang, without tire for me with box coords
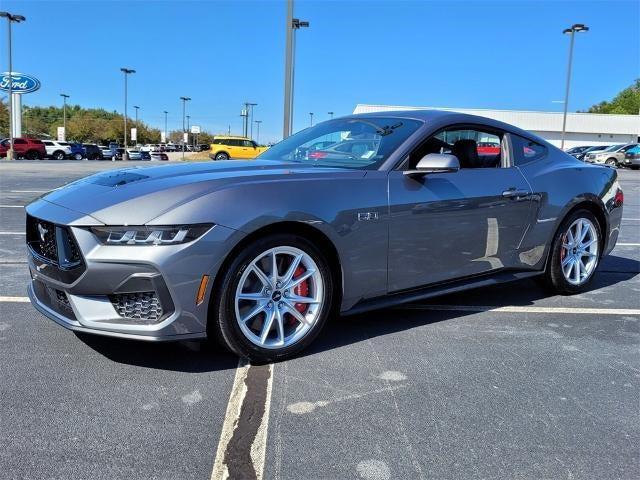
[560,218,599,285]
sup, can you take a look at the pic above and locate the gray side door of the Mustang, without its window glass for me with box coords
[388,125,531,291]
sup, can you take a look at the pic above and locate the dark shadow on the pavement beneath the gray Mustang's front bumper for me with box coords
[76,333,238,373]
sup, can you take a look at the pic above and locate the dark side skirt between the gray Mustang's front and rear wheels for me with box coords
[341,271,544,316]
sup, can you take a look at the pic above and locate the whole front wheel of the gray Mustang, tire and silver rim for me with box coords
[208,234,333,362]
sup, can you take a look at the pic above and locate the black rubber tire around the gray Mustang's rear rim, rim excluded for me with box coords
[544,209,604,295]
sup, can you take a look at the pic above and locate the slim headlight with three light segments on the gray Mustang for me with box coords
[91,223,213,245]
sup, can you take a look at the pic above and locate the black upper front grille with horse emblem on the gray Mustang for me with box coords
[27,215,82,270]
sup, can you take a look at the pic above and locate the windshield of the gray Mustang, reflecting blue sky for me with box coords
[258,117,422,170]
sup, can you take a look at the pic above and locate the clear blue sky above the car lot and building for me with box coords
[0,0,640,141]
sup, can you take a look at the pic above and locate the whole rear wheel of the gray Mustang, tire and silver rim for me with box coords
[545,210,603,295]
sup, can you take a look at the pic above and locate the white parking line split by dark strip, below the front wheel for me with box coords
[211,359,273,480]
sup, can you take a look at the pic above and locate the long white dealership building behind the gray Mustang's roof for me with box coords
[353,104,640,148]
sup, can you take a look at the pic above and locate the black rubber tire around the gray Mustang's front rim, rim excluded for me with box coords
[212,234,334,363]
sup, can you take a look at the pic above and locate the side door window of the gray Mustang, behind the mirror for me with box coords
[409,127,502,168]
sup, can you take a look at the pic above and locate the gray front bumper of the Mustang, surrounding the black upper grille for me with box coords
[27,200,237,341]
